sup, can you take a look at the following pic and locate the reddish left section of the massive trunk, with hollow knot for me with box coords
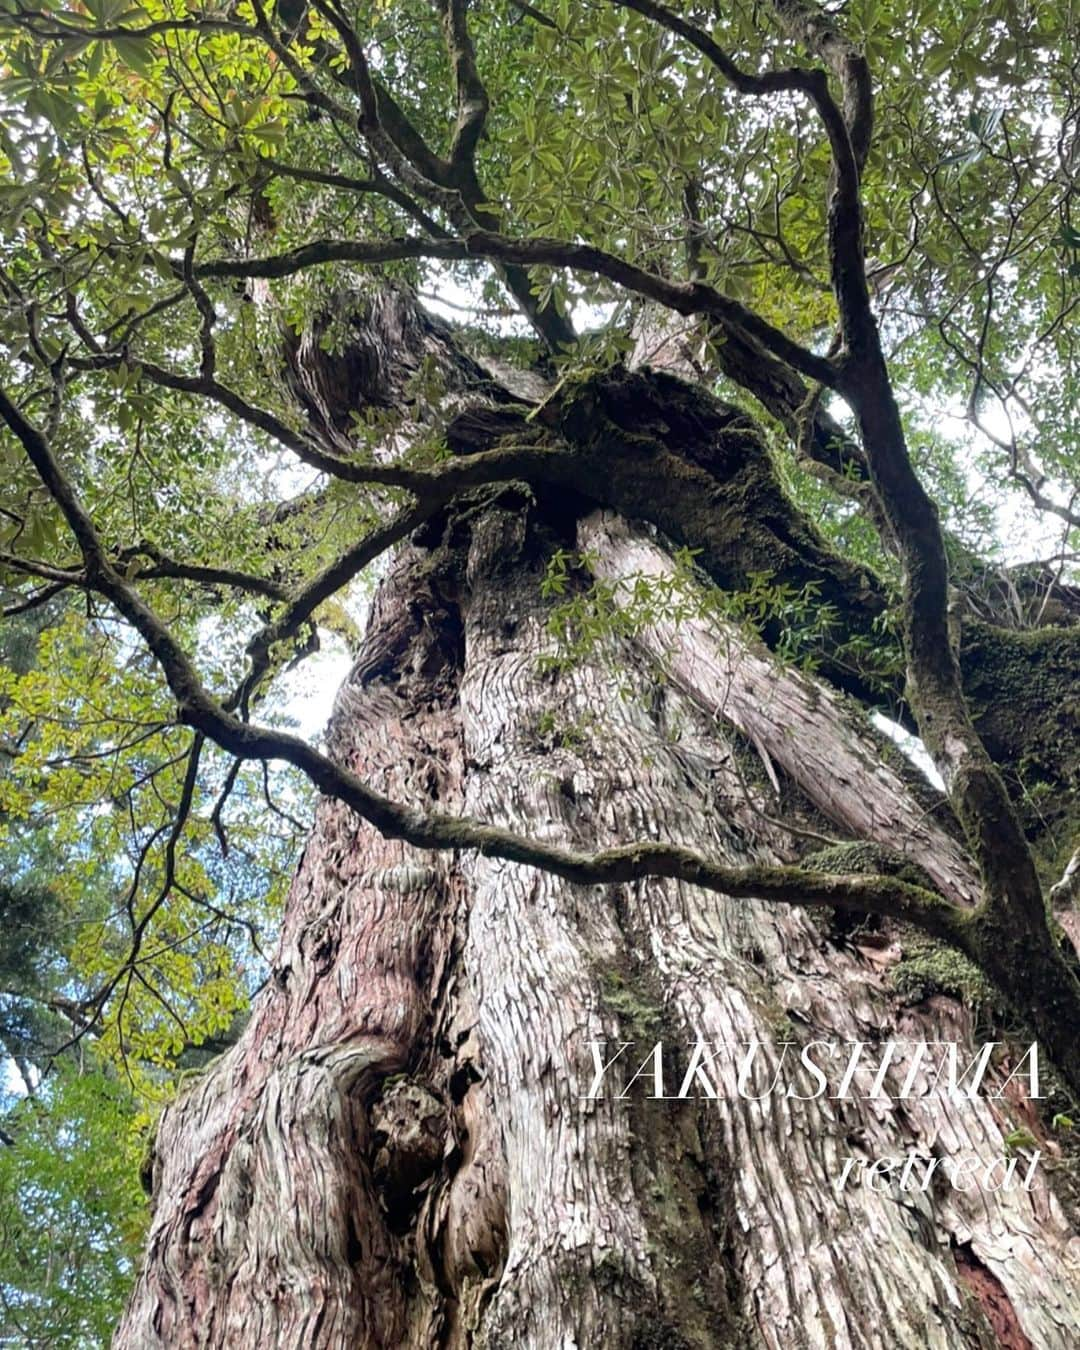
[116,545,504,1350]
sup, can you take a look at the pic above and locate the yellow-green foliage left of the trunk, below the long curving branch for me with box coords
[0,609,299,1098]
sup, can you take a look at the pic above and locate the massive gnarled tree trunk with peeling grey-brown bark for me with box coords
[115,495,1080,1350]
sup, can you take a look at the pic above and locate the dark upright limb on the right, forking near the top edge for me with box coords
[666,0,1046,930]
